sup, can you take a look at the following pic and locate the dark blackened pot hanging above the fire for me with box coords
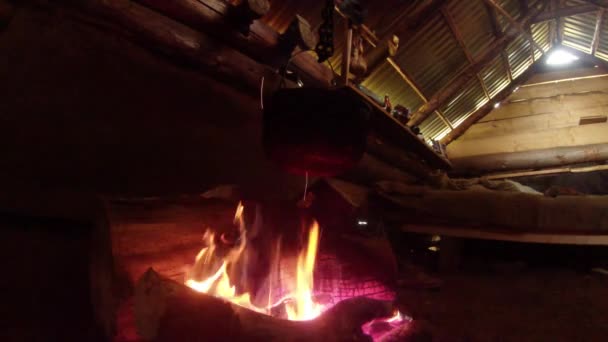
[263,88,371,176]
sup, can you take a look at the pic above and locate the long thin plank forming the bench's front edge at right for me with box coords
[401,224,608,246]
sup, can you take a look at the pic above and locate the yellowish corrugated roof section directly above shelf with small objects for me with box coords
[362,62,423,110]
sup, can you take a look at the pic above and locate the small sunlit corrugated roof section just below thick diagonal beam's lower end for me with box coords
[441,79,488,127]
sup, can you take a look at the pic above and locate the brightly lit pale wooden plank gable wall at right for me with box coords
[448,69,608,170]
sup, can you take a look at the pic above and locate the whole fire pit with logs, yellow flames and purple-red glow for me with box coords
[108,191,411,341]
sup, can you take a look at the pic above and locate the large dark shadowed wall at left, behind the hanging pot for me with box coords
[0,7,304,199]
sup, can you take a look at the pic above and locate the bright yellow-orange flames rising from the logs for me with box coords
[185,203,324,321]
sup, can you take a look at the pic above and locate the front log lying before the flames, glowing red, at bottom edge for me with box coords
[135,269,393,341]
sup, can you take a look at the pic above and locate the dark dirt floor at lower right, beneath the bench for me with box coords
[399,238,608,341]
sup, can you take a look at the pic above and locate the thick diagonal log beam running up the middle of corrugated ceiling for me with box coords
[408,1,544,127]
